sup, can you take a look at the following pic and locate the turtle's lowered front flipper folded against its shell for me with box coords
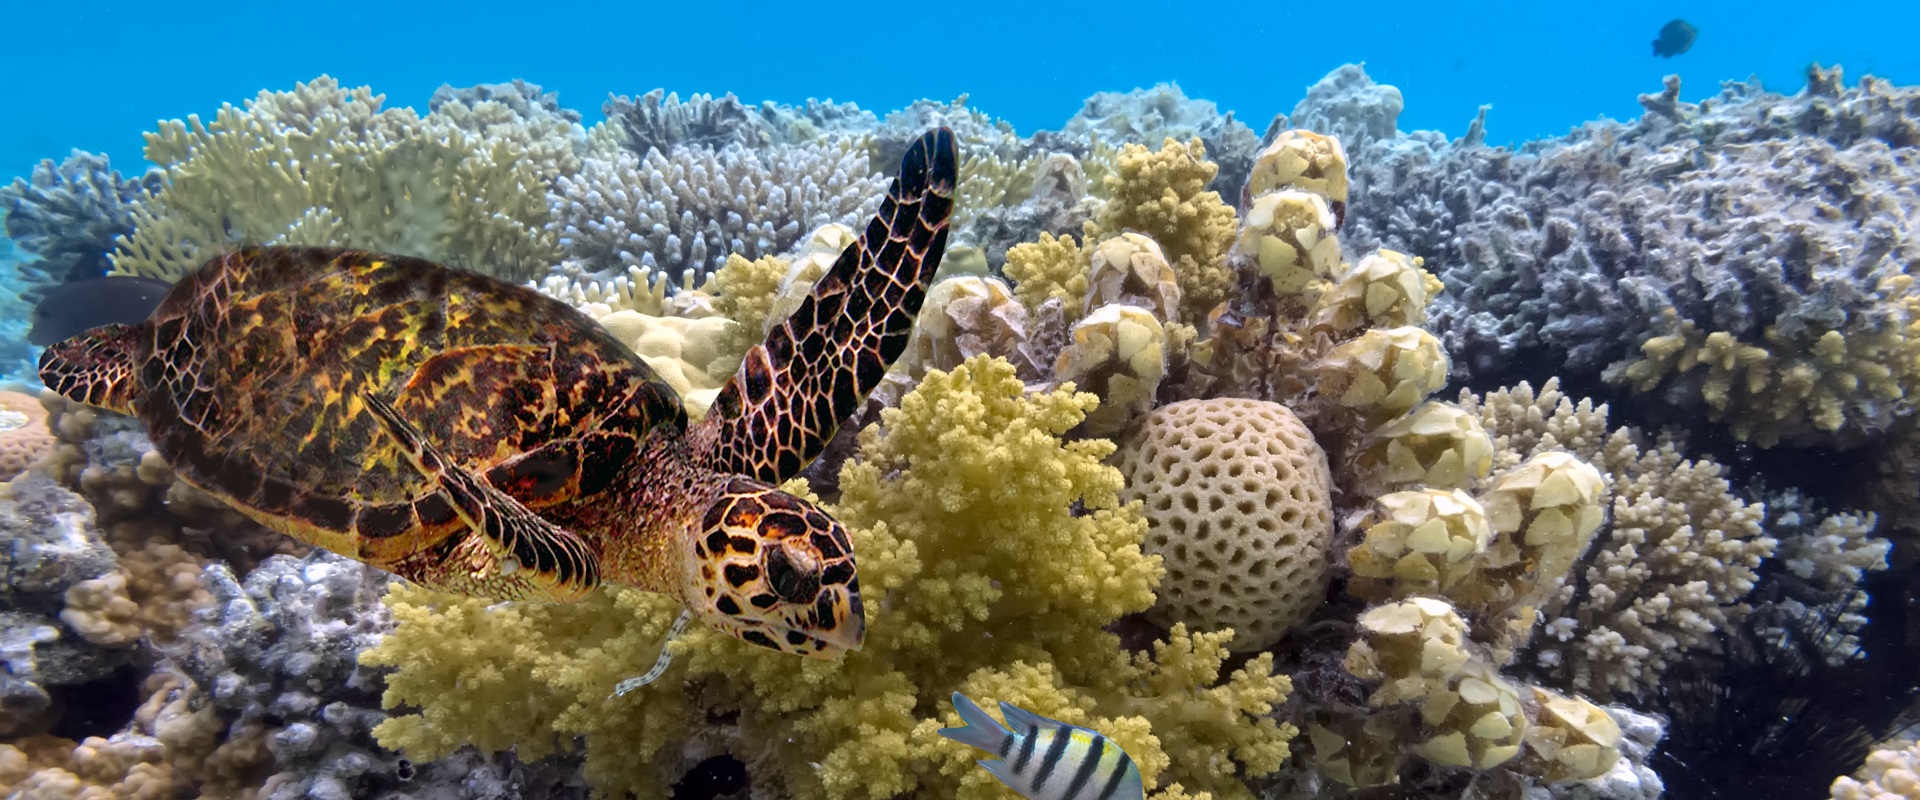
[361,391,599,602]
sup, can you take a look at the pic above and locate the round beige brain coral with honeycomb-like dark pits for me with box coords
[1117,397,1332,650]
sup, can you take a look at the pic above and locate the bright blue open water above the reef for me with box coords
[0,0,1920,178]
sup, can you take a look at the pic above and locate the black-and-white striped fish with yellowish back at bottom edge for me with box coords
[941,693,1146,800]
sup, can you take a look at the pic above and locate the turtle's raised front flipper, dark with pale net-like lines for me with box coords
[703,129,960,483]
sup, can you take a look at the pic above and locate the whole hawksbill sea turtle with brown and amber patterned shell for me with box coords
[40,129,958,658]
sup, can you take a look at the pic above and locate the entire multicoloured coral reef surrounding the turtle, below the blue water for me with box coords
[0,65,1920,800]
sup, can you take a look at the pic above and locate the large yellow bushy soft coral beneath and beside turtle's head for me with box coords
[365,357,1292,800]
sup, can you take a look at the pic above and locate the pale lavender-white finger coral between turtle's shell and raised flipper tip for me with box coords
[547,140,885,284]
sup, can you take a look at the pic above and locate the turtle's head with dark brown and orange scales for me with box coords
[685,476,866,658]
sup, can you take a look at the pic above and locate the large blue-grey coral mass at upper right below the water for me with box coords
[1328,62,1920,447]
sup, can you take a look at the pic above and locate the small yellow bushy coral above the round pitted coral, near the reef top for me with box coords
[1100,138,1236,320]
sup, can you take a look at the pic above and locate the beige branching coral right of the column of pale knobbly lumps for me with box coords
[1459,380,1776,696]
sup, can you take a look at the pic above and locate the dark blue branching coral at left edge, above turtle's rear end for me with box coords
[0,150,163,284]
